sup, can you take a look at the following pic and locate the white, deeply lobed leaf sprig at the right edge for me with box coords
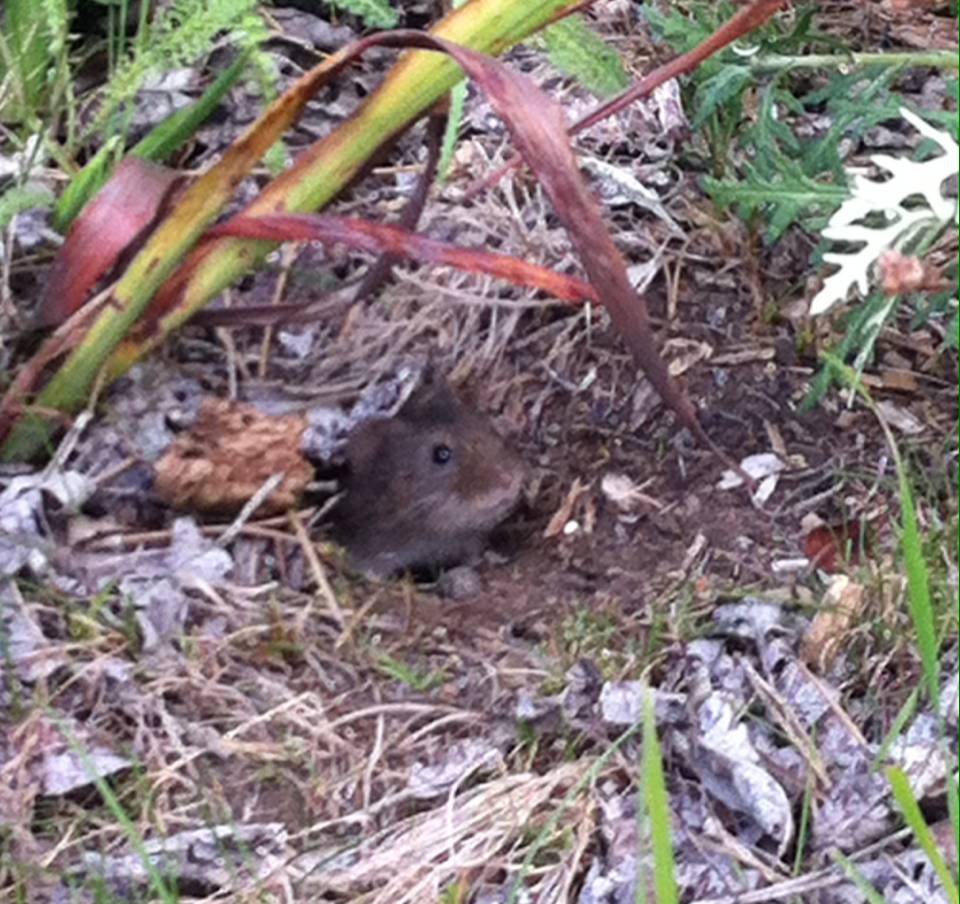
[810,108,960,315]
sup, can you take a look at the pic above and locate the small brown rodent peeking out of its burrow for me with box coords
[334,378,526,577]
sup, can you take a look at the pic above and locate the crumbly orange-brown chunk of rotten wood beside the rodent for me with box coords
[154,399,313,515]
